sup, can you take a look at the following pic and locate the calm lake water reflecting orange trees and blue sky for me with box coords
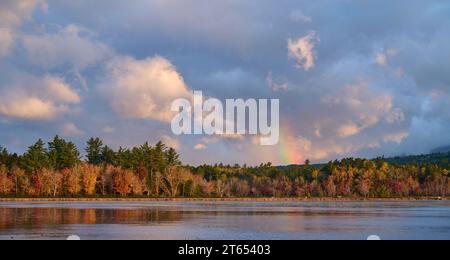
[0,201,450,240]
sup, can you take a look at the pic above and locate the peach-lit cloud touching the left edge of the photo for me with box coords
[0,74,80,120]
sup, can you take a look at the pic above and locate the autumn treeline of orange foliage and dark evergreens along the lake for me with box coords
[0,136,450,198]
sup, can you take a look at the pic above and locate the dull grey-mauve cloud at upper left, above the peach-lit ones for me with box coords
[22,25,112,70]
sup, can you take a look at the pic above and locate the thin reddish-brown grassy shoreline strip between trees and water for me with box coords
[0,197,450,203]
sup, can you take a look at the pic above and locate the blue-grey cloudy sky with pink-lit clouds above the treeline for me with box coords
[0,0,450,165]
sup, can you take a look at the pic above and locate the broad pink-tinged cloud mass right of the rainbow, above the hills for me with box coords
[276,77,409,161]
